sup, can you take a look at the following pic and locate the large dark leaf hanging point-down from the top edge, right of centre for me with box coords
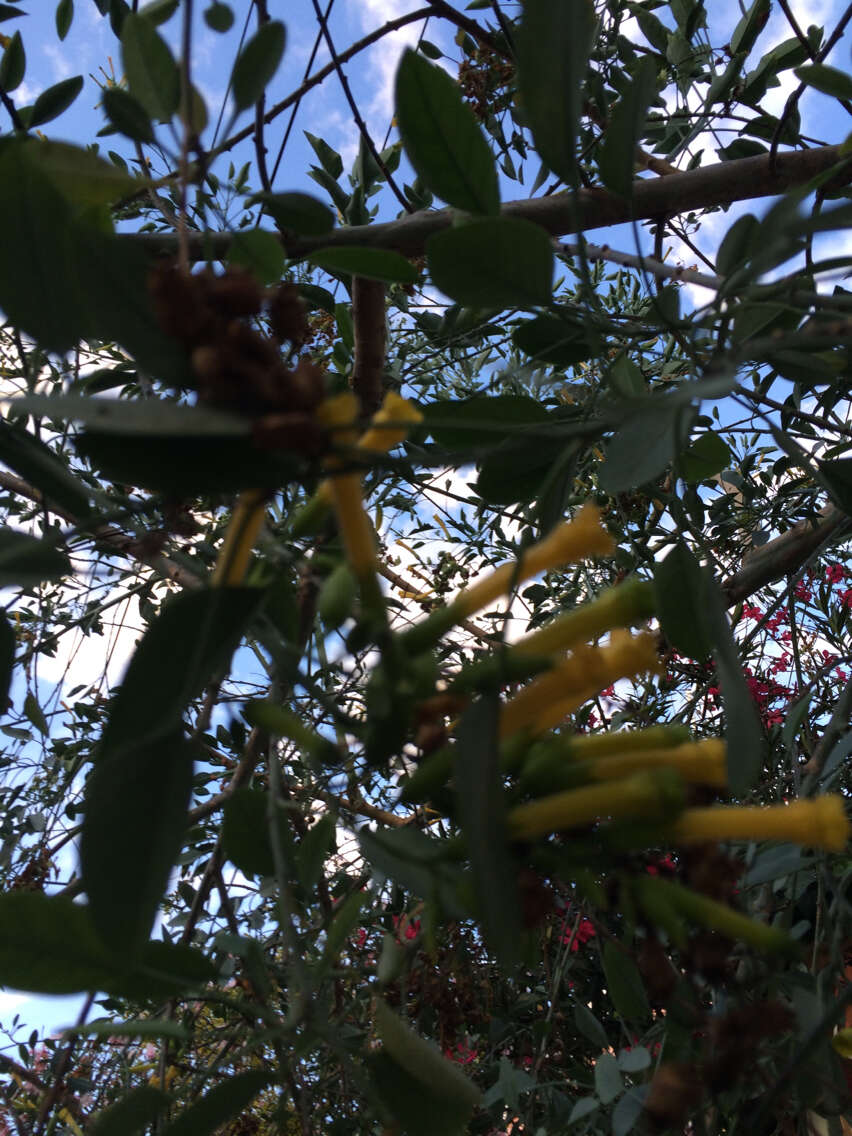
[518,0,598,185]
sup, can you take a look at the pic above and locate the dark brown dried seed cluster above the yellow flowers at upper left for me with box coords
[149,262,325,429]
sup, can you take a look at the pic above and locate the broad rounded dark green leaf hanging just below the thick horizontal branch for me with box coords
[426,217,553,308]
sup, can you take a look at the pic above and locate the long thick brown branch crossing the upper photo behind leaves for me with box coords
[128,145,850,260]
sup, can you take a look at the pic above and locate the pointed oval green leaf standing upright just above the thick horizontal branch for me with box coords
[395,48,500,214]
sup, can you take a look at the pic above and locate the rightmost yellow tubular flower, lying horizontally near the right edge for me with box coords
[667,793,850,852]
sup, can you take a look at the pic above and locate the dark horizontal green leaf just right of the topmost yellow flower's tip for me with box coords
[420,394,549,451]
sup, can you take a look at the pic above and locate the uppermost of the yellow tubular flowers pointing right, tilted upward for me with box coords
[450,504,616,621]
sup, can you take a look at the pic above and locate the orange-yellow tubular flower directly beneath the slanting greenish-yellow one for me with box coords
[500,632,659,737]
